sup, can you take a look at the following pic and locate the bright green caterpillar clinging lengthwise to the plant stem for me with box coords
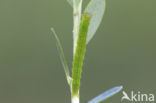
[72,14,91,96]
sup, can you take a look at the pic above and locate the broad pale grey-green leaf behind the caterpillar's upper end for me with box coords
[84,0,106,43]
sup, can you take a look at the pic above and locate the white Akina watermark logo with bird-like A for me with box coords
[121,91,154,102]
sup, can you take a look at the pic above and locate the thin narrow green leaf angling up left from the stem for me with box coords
[51,28,72,85]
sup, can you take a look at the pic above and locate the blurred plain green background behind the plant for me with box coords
[0,0,156,103]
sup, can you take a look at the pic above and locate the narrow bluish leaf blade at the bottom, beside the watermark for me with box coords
[88,86,123,103]
